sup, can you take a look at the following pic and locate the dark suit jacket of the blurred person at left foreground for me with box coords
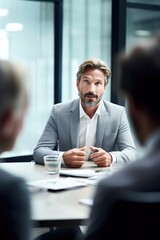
[0,169,31,240]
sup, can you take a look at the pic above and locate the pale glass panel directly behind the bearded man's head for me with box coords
[62,0,111,101]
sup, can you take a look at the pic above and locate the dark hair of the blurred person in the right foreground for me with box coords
[118,34,160,119]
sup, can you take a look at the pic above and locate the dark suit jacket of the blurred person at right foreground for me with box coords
[84,134,160,240]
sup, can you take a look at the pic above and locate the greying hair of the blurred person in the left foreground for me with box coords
[0,60,26,116]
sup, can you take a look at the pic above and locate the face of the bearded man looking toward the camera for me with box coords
[77,68,106,107]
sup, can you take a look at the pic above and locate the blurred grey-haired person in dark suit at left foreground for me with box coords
[0,60,31,240]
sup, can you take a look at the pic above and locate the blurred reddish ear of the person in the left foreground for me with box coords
[0,111,15,136]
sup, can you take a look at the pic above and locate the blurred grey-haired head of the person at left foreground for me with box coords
[0,60,28,153]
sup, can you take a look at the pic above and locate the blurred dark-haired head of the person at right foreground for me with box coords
[119,36,160,145]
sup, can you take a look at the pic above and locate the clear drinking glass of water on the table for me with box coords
[43,154,61,178]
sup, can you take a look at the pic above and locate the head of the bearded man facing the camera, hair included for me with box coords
[77,58,111,107]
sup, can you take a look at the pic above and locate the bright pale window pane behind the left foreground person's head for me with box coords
[0,0,54,157]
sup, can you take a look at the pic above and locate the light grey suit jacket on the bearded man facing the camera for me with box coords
[33,99,136,164]
